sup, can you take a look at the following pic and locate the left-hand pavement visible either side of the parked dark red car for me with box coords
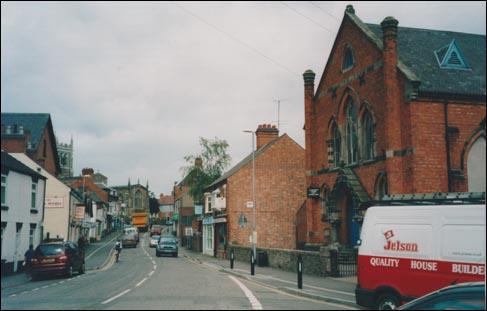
[1,231,120,290]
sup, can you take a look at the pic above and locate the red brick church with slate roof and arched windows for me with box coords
[303,6,486,247]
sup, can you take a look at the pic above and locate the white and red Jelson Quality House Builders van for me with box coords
[355,205,486,310]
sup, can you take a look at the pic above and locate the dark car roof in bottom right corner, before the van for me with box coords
[397,282,485,310]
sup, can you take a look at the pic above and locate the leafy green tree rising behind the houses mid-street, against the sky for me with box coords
[181,137,231,204]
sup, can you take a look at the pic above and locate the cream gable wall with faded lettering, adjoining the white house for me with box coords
[10,153,80,242]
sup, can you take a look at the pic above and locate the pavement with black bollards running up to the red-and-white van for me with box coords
[179,247,362,309]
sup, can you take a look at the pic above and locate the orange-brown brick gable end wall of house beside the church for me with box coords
[227,135,306,249]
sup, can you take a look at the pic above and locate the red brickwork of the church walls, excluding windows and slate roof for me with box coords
[304,10,485,249]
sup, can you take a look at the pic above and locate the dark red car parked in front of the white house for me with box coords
[31,241,85,279]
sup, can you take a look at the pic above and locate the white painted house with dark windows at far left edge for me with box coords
[1,151,46,273]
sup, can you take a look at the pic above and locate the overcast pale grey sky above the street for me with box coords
[1,1,486,195]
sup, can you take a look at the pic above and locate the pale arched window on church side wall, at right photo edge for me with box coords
[467,136,486,192]
